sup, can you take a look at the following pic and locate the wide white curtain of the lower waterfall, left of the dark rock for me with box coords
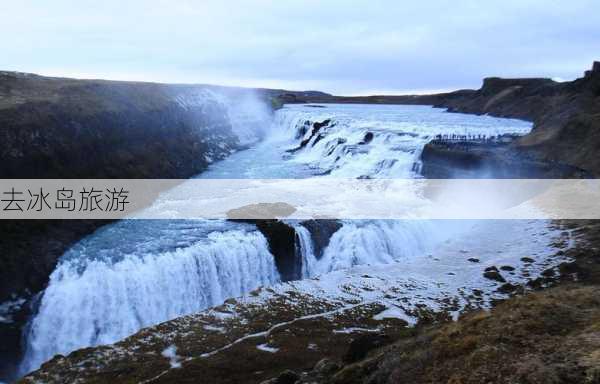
[21,230,279,373]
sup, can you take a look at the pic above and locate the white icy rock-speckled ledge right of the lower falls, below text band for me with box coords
[238,220,567,324]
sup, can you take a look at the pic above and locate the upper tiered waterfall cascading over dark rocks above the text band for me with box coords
[275,105,531,178]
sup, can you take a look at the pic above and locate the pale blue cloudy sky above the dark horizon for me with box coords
[0,0,600,95]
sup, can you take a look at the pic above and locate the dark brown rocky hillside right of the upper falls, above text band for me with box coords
[422,62,600,177]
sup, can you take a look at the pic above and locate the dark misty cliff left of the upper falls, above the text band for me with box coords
[0,72,244,178]
